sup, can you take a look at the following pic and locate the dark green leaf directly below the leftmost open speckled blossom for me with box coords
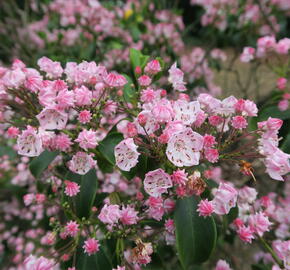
[29,150,58,178]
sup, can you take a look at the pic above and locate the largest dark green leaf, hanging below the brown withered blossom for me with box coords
[174,196,217,269]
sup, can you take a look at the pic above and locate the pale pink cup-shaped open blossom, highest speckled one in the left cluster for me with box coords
[36,108,68,129]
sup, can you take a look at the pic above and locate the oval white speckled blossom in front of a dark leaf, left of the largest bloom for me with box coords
[115,138,140,171]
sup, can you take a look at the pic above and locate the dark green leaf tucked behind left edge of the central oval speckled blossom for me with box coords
[97,132,124,166]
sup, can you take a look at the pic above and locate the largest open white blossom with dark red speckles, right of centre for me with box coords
[166,128,203,167]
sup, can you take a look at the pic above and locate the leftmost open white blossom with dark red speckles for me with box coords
[17,126,43,157]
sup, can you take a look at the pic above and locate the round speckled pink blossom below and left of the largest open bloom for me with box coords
[144,169,172,197]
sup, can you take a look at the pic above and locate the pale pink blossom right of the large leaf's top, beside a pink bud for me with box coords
[212,183,238,215]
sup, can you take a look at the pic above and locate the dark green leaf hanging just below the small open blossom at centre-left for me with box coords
[67,169,98,218]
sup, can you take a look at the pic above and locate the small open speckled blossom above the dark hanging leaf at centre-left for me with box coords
[68,152,96,175]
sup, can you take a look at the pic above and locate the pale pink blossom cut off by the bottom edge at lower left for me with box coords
[21,255,57,270]
